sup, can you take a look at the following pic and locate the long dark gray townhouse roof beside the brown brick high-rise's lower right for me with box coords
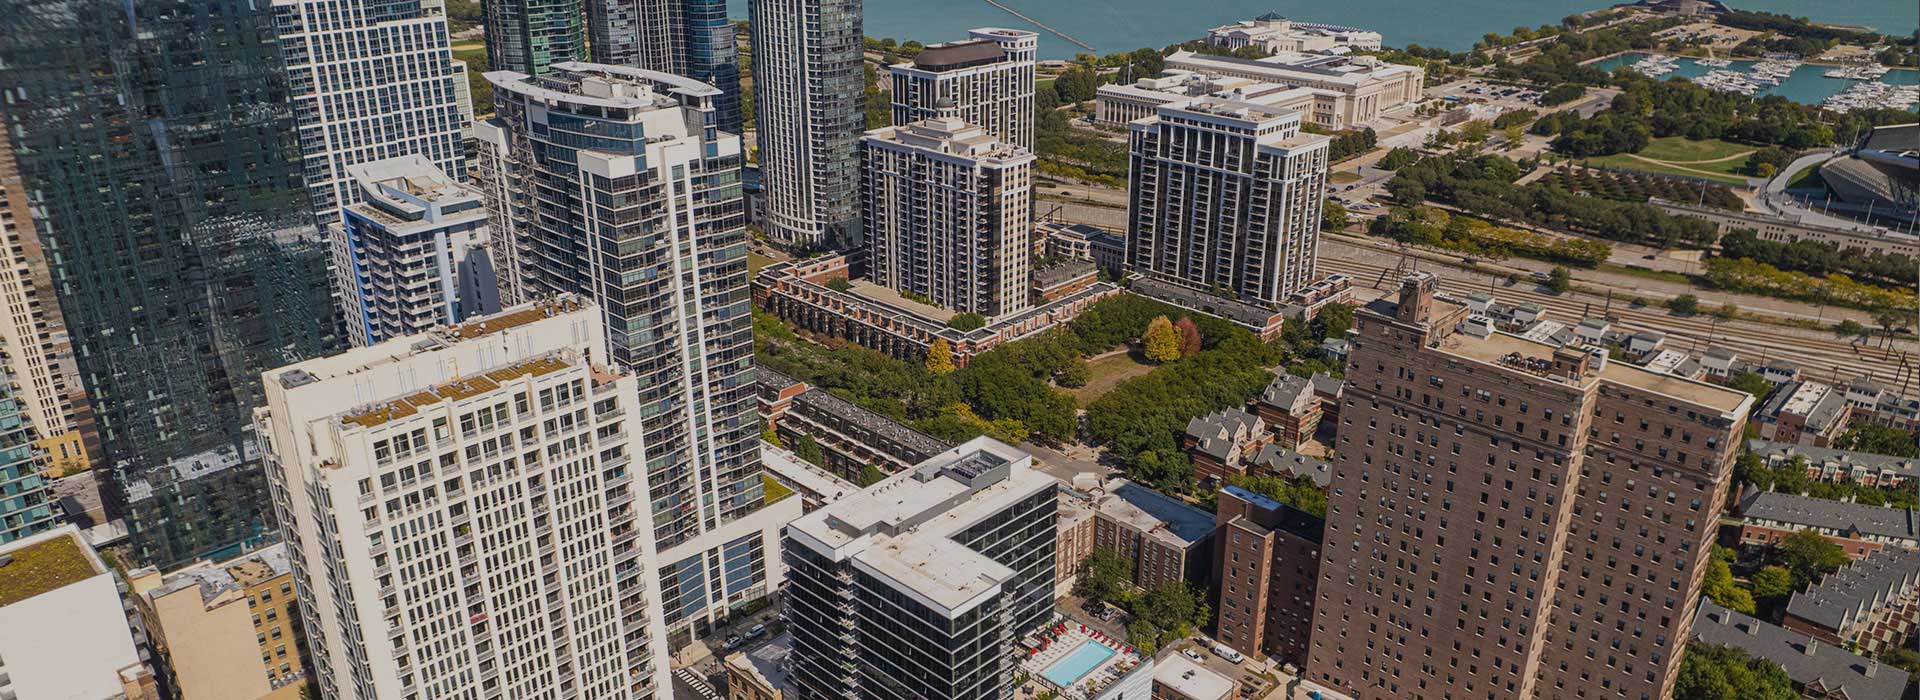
[1693,600,1907,700]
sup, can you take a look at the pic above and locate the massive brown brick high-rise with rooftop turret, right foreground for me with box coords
[1308,274,1753,700]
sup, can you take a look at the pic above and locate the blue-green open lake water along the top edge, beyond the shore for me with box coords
[728,0,1920,58]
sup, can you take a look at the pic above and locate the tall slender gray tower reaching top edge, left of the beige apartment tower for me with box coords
[749,0,866,249]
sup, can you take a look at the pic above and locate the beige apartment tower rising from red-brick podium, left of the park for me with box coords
[860,119,1033,318]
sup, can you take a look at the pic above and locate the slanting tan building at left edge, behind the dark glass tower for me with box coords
[0,126,100,476]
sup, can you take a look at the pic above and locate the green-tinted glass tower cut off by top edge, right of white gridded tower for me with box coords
[482,0,588,75]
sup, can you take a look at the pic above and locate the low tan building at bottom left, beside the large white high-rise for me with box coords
[129,545,307,700]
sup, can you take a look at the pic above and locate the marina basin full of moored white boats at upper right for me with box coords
[1594,52,1920,111]
